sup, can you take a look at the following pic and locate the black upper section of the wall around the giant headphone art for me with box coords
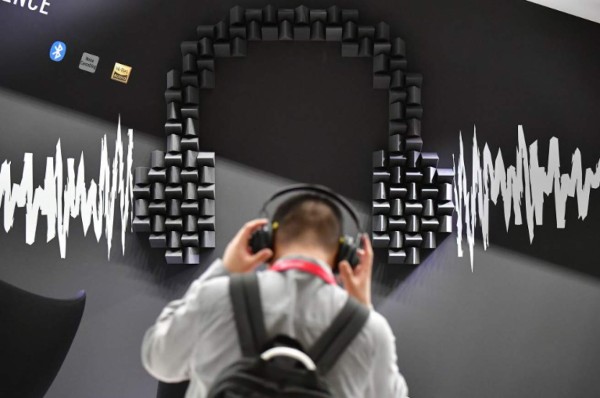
[0,0,600,277]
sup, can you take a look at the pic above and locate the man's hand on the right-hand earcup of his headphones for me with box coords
[339,234,373,308]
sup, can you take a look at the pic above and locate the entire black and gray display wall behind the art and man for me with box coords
[0,0,600,398]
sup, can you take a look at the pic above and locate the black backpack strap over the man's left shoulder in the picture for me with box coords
[229,272,267,357]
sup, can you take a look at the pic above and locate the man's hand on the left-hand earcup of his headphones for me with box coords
[223,218,273,273]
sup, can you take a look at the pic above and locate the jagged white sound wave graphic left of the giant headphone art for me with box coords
[0,116,133,259]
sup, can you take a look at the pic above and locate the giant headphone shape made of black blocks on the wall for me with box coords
[132,5,454,265]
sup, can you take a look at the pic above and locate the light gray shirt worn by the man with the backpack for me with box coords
[142,259,408,398]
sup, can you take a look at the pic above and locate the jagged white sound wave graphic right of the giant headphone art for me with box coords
[453,125,600,271]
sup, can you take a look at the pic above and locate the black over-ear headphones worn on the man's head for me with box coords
[250,184,362,269]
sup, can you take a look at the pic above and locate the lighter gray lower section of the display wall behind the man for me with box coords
[0,90,600,398]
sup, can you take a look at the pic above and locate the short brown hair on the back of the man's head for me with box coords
[273,193,343,251]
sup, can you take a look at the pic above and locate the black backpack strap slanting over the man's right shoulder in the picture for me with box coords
[308,296,370,375]
